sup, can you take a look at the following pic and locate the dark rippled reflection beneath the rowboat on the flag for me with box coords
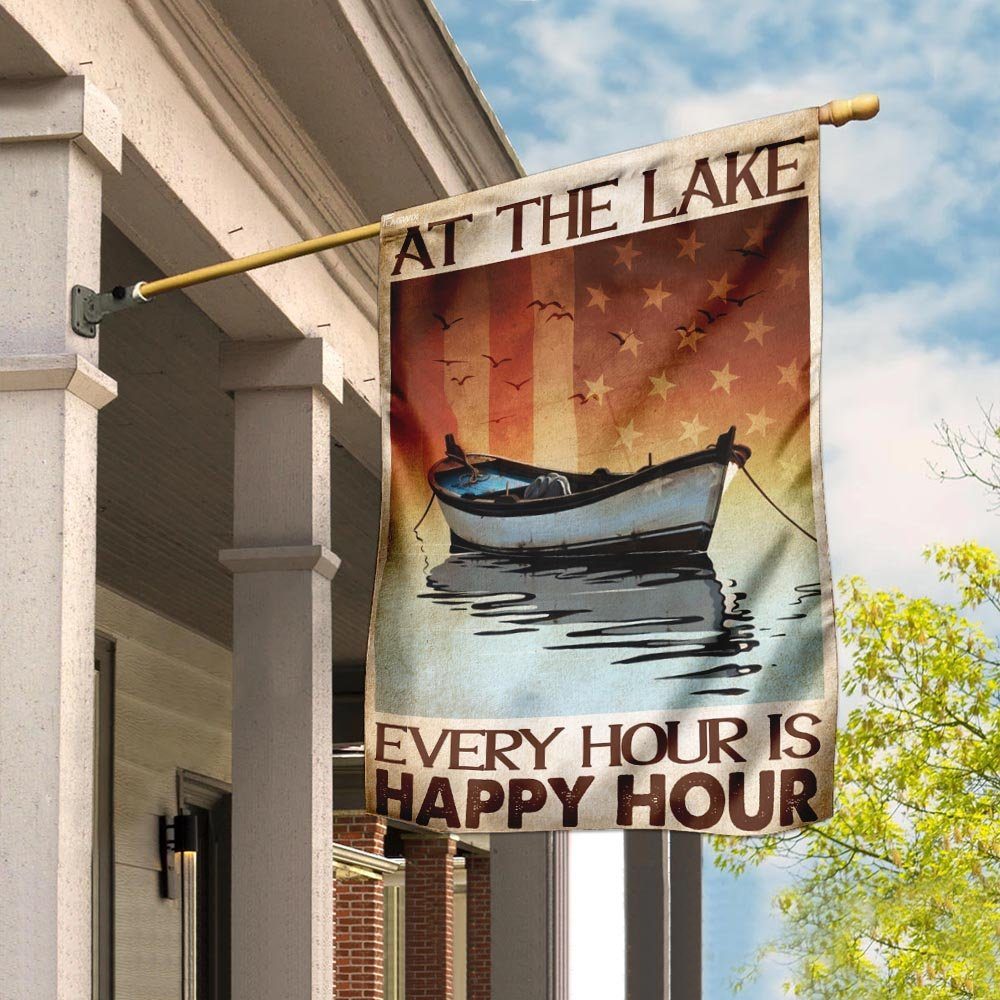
[420,552,761,680]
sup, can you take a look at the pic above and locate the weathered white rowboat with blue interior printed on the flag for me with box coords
[427,427,750,555]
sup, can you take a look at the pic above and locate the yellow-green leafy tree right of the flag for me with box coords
[714,543,1000,1000]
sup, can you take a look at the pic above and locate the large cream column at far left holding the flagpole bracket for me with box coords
[0,77,121,1000]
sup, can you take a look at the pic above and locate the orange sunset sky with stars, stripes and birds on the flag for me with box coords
[391,198,811,526]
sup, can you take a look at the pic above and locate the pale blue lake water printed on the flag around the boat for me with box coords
[376,472,829,720]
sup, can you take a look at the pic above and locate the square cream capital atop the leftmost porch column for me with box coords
[0,76,122,173]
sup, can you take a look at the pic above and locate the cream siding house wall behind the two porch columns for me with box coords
[96,586,232,1000]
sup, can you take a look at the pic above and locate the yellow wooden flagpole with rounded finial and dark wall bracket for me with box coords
[70,94,879,337]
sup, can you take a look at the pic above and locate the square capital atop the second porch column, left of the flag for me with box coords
[219,337,344,402]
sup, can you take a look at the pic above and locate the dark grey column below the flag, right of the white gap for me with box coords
[625,830,701,1000]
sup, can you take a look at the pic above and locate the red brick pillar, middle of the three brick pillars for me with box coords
[403,834,456,1000]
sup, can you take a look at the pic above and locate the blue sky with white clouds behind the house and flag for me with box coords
[437,0,1000,1000]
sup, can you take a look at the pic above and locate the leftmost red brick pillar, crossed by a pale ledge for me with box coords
[333,813,386,1000]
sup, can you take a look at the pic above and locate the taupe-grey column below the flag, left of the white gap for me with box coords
[490,831,569,1000]
